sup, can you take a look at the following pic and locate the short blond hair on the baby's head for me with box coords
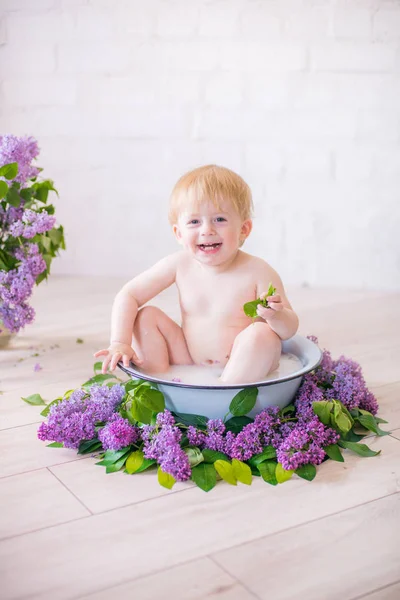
[168,165,253,225]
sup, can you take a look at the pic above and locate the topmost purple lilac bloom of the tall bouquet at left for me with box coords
[0,134,39,185]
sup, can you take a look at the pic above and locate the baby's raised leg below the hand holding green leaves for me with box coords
[220,322,282,383]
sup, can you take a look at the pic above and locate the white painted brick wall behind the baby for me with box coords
[0,0,400,290]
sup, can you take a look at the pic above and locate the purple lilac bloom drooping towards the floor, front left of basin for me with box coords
[142,425,191,481]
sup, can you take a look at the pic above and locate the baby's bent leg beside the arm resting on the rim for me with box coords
[133,306,193,373]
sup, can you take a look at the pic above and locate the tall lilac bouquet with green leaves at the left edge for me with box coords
[0,135,65,347]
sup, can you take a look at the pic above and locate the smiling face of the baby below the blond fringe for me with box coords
[173,200,252,266]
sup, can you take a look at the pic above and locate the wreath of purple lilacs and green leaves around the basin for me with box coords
[32,336,389,492]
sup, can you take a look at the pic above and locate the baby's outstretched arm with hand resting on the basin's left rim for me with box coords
[94,252,180,373]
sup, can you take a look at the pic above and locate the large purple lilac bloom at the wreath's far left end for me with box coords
[38,385,124,448]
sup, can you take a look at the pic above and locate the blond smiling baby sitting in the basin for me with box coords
[94,165,299,384]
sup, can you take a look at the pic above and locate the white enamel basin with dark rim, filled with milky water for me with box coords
[118,335,322,419]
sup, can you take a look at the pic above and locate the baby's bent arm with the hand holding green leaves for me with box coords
[257,263,299,340]
